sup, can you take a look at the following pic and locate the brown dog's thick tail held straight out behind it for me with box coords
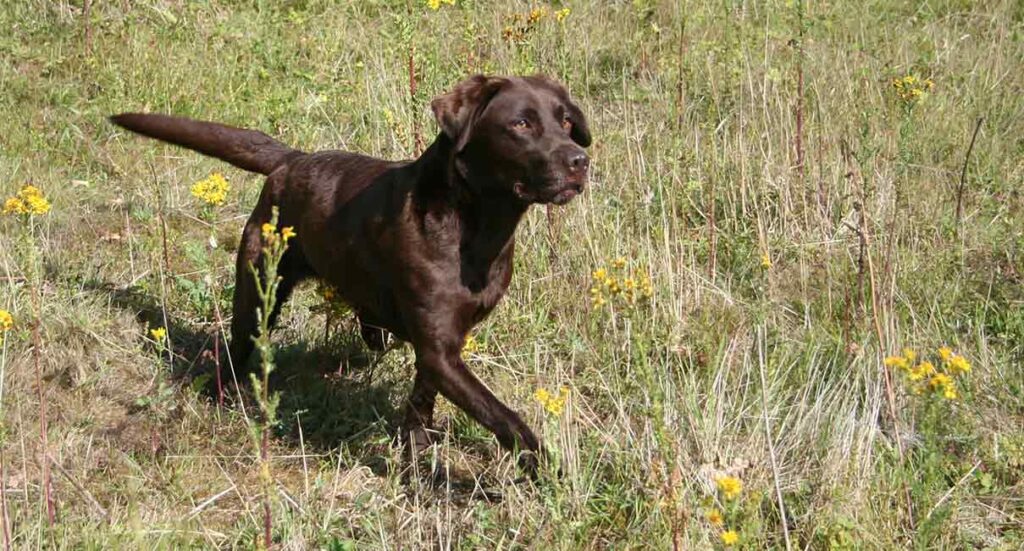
[111,113,302,174]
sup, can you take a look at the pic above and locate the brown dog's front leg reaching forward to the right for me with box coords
[414,342,543,477]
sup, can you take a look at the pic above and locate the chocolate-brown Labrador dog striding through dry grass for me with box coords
[111,75,591,477]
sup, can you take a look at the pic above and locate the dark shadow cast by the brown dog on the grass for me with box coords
[86,283,512,502]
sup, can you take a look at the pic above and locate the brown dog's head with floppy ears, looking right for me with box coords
[430,75,591,205]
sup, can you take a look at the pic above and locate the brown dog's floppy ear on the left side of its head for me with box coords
[430,75,508,151]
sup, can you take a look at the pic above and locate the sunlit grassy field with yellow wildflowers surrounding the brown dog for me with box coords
[0,0,1024,550]
